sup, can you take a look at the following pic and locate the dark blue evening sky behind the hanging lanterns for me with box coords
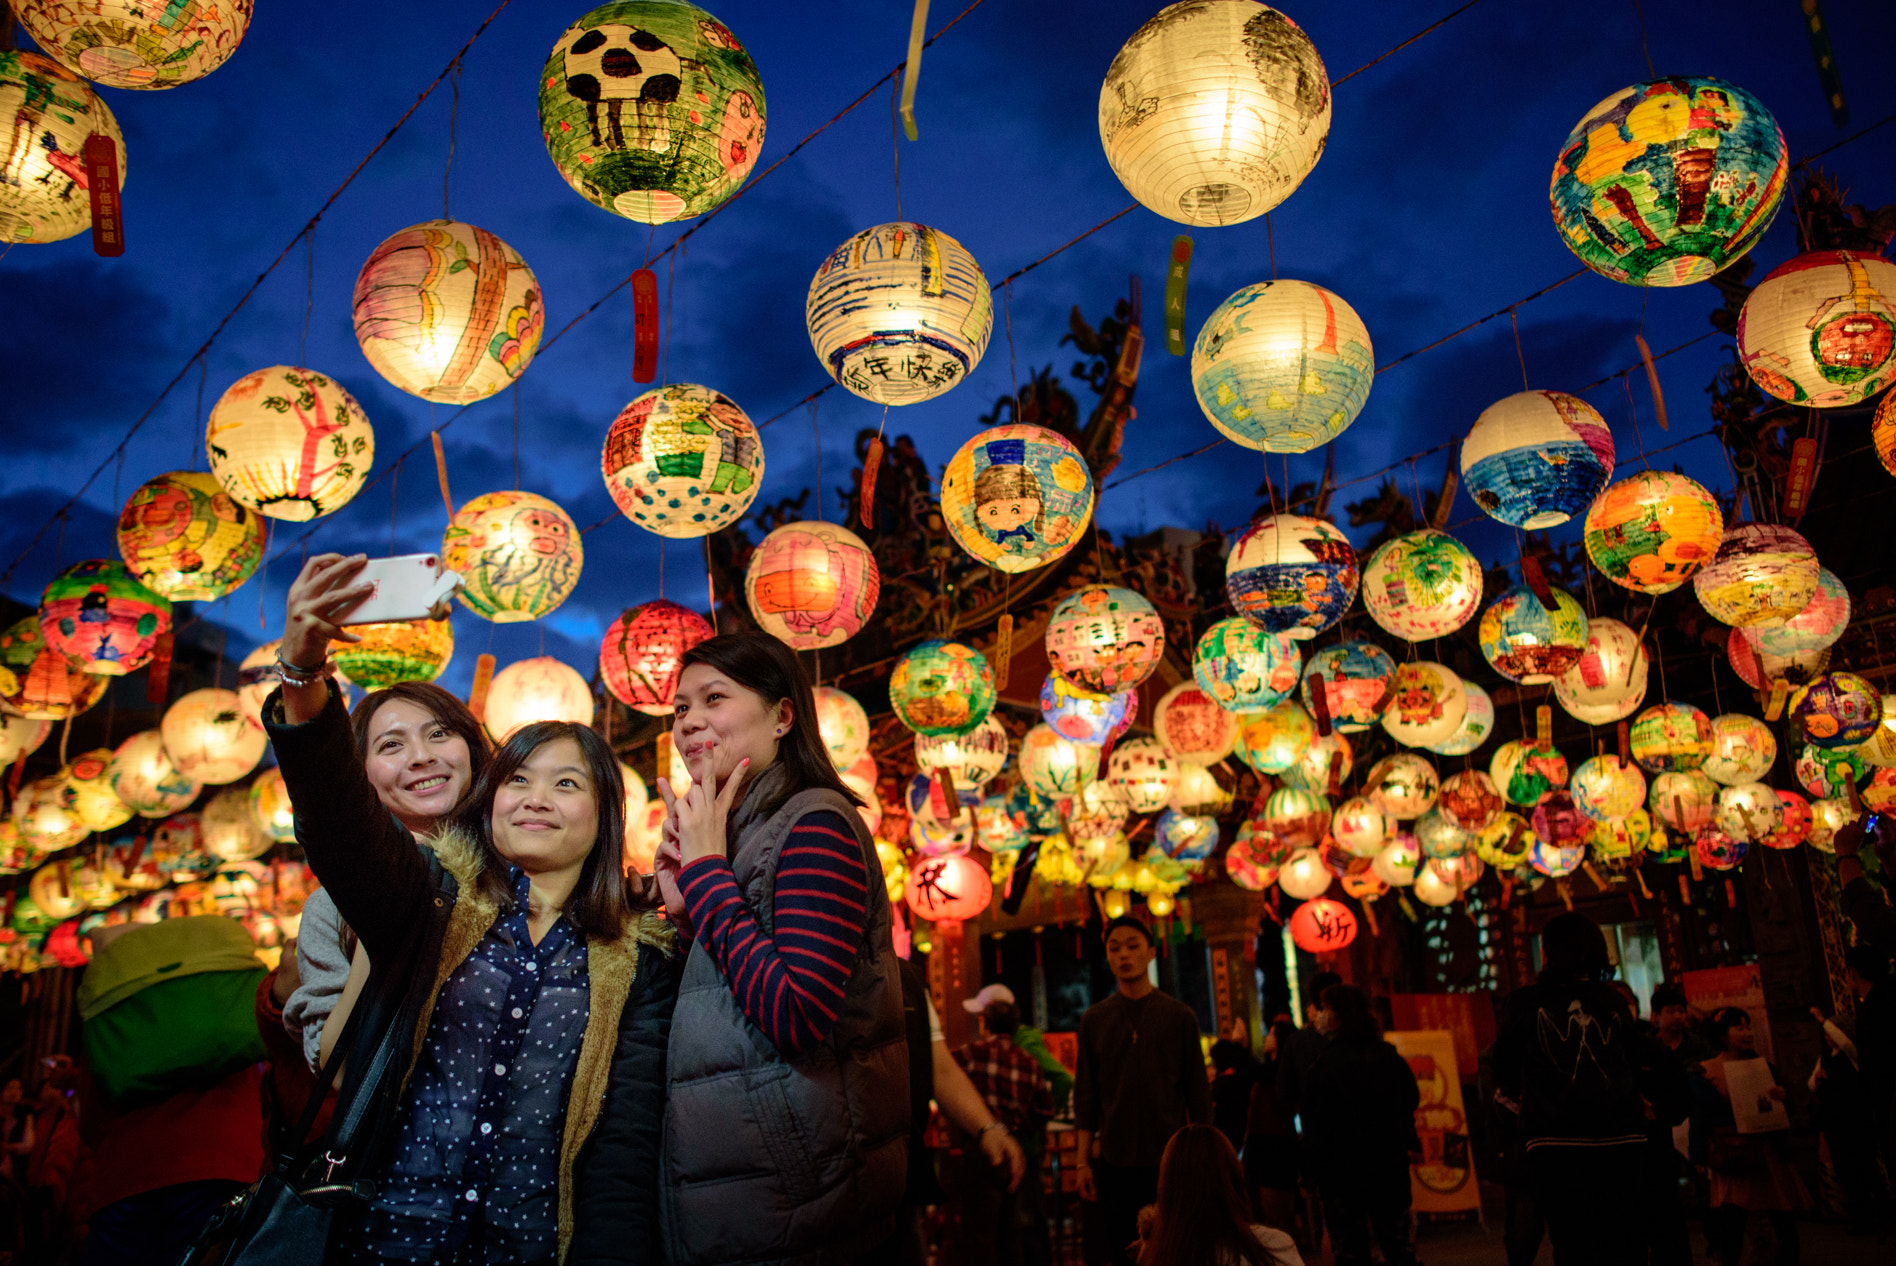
[0,0,1896,688]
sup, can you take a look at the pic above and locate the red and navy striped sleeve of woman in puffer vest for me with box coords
[679,811,868,1056]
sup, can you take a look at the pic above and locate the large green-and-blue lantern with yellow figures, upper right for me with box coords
[1547,76,1790,286]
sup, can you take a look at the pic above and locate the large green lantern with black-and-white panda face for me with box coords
[540,0,764,224]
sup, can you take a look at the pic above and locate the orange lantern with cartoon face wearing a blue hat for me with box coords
[940,423,1092,576]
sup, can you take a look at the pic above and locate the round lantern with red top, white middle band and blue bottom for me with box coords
[1462,390,1613,531]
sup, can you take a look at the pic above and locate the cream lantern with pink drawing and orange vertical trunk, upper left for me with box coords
[353,220,546,406]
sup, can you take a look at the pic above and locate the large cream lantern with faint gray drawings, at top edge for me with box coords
[1100,0,1329,227]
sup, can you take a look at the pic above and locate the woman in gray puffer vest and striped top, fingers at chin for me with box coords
[571,633,908,1266]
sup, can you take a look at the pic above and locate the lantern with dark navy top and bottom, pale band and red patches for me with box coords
[1225,514,1361,639]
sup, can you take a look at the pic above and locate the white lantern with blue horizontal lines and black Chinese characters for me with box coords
[804,222,993,405]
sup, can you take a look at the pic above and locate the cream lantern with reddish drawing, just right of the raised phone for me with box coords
[442,491,586,624]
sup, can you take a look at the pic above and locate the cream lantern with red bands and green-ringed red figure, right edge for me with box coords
[1737,250,1896,409]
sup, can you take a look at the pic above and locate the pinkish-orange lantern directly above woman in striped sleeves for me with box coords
[743,519,882,650]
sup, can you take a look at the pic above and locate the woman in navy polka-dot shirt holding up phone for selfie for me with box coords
[264,555,677,1264]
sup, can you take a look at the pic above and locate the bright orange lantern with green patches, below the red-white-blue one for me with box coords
[1585,470,1725,593]
